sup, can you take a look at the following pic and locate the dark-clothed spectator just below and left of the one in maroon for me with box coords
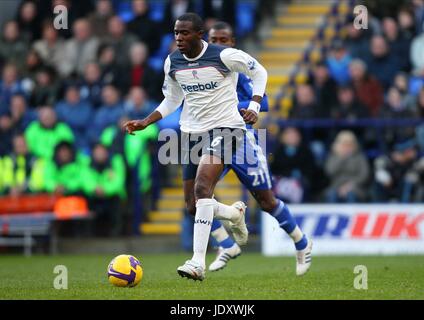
[331,84,368,120]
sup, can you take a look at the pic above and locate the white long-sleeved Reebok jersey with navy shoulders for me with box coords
[156,41,267,133]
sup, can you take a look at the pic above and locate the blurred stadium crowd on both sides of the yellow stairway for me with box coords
[0,0,424,232]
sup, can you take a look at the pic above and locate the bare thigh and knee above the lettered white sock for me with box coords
[194,154,224,199]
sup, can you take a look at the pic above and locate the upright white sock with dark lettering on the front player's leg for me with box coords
[192,199,215,268]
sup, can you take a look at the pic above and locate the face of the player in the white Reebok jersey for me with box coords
[174,20,202,55]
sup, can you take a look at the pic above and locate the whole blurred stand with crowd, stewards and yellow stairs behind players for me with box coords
[0,0,424,252]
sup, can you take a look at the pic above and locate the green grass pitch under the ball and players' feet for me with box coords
[0,253,424,300]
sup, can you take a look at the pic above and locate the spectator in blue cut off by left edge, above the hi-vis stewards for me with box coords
[0,64,24,114]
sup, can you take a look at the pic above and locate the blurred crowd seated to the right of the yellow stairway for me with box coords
[271,0,424,203]
